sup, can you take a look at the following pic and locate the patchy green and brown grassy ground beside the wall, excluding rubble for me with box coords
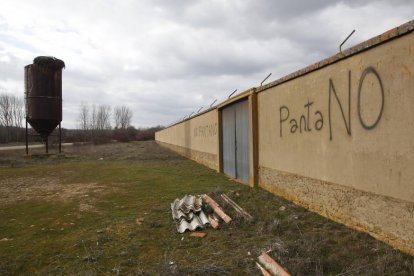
[0,142,414,275]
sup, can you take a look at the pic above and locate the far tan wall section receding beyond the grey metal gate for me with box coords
[155,109,219,170]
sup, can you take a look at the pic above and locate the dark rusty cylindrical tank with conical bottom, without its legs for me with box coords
[24,56,65,140]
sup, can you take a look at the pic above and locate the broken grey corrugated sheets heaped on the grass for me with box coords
[171,195,209,233]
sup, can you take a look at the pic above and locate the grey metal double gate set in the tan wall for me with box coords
[222,100,250,183]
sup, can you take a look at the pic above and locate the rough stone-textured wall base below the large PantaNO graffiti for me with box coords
[259,167,414,255]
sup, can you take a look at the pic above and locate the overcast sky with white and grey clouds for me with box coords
[0,0,414,128]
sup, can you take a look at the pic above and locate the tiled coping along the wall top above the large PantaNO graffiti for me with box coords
[256,20,414,93]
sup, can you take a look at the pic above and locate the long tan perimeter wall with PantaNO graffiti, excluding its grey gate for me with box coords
[157,21,414,254]
